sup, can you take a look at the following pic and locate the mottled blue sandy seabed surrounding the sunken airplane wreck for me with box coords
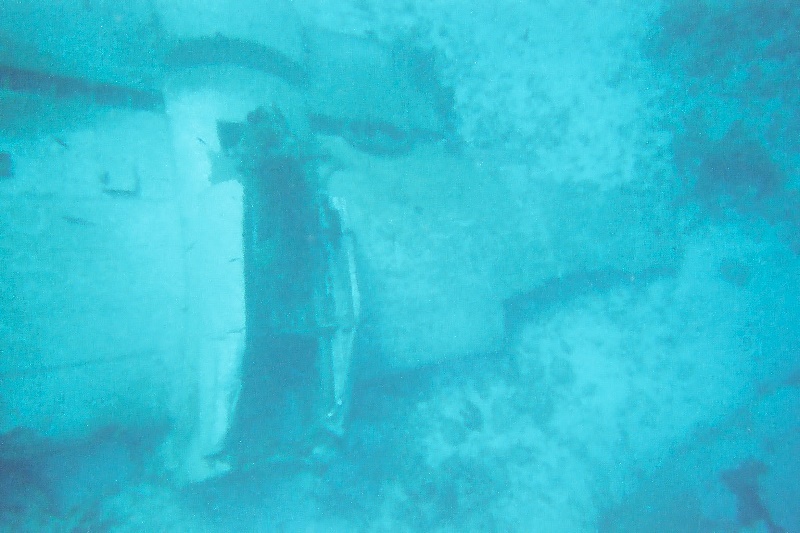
[0,0,800,532]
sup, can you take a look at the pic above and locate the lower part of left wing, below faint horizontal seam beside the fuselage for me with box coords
[0,193,185,434]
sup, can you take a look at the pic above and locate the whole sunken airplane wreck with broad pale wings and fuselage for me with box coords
[0,0,676,482]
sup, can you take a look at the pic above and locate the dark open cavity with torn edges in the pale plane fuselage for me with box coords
[218,107,360,463]
